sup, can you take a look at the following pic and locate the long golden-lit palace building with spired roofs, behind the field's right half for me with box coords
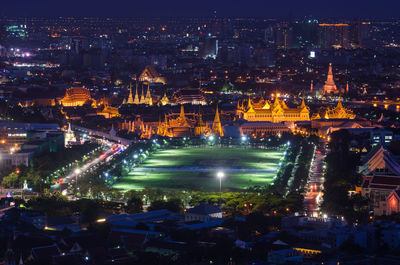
[236,97,310,123]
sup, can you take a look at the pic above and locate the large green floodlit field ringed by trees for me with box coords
[114,147,284,191]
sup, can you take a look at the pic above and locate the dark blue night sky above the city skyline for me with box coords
[0,0,400,18]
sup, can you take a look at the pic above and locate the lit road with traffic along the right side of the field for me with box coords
[304,143,326,216]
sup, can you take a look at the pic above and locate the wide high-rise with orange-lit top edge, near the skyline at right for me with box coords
[319,23,350,49]
